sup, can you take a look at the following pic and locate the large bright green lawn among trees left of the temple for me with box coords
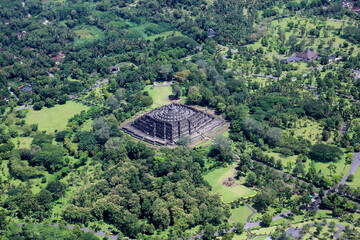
[25,101,89,132]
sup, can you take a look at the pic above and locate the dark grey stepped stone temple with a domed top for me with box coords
[123,103,226,146]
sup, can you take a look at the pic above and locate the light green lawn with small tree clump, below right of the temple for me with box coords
[204,165,256,202]
